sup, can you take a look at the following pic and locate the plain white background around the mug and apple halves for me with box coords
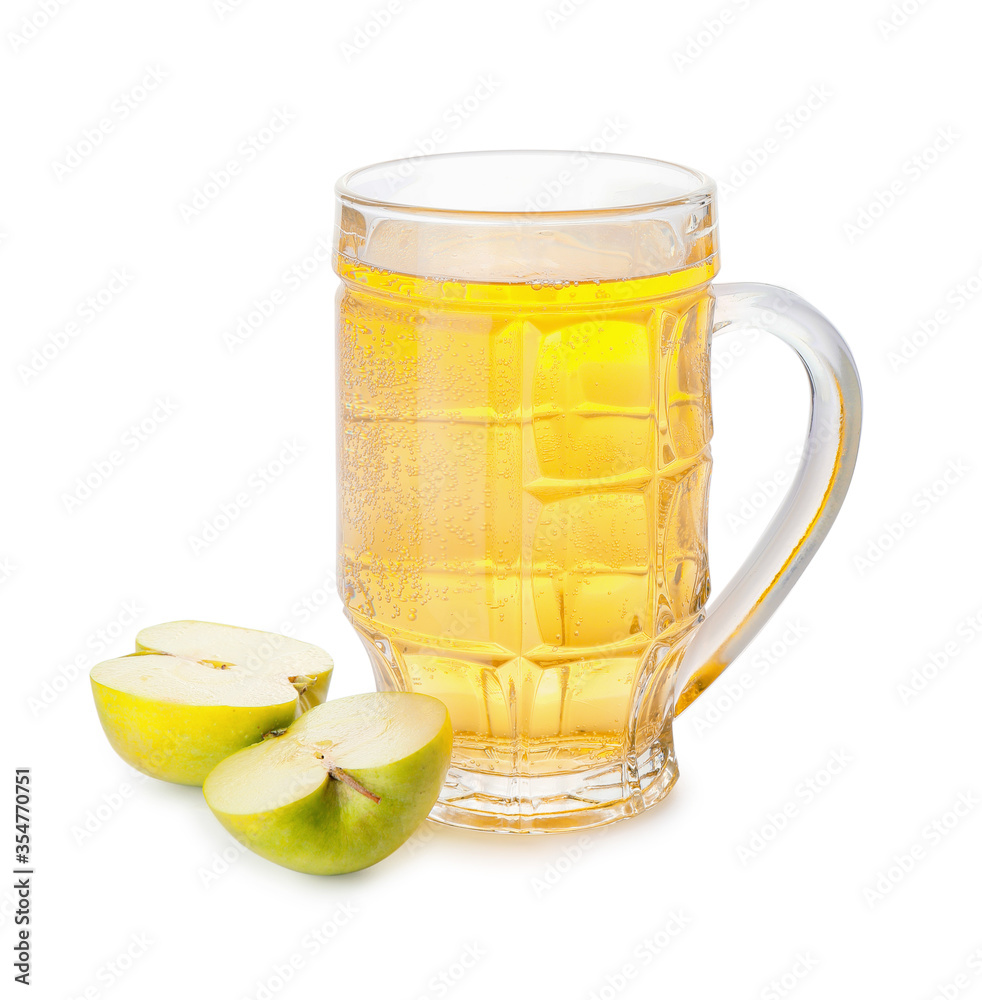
[0,0,982,1000]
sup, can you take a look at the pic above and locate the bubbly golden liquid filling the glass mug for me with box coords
[336,257,712,773]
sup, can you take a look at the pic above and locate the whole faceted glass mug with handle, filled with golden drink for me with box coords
[335,152,861,832]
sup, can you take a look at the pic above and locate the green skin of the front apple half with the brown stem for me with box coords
[204,714,453,875]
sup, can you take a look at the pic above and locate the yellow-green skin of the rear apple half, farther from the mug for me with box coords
[92,680,297,785]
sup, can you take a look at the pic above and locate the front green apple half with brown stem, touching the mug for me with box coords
[204,691,452,875]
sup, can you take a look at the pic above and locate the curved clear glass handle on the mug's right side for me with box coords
[675,282,862,715]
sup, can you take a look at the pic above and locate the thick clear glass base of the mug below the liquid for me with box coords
[429,742,678,833]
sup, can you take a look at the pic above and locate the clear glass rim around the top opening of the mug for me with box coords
[334,149,716,222]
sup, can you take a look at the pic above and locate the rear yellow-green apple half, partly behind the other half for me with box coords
[90,621,333,785]
